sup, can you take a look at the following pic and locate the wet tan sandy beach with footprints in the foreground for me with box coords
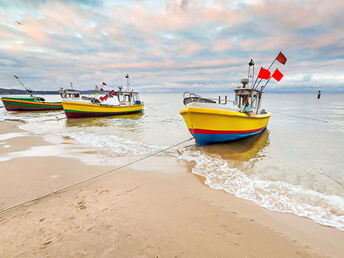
[0,121,344,257]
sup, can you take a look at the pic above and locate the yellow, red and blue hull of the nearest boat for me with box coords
[180,107,271,146]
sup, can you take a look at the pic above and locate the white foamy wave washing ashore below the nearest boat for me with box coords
[179,150,344,231]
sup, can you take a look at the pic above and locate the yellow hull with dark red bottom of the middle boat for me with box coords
[62,101,143,118]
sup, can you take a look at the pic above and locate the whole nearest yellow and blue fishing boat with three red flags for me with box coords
[180,52,286,146]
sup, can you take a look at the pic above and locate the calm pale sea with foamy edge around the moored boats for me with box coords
[0,93,344,231]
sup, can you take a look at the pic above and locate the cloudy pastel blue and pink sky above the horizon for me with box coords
[0,0,344,93]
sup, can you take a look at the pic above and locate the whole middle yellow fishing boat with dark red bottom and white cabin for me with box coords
[62,75,143,118]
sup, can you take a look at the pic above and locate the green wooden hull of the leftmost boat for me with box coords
[1,97,63,111]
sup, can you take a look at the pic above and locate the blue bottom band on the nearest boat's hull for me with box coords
[192,128,265,146]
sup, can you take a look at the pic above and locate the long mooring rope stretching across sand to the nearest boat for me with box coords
[0,137,193,214]
